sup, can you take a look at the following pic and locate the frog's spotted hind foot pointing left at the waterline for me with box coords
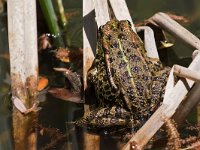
[75,106,131,128]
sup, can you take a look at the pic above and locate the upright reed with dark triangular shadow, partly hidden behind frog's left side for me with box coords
[83,0,100,150]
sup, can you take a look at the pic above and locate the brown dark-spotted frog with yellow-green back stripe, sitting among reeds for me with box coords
[76,20,170,131]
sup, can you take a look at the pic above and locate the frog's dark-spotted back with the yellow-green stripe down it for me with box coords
[112,21,152,99]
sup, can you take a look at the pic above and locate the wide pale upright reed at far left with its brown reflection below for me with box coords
[7,0,38,150]
